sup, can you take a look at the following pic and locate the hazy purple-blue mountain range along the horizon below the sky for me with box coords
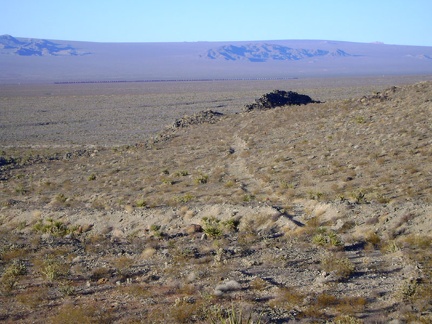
[0,35,432,84]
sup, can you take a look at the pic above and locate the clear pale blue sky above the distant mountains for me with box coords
[0,0,432,46]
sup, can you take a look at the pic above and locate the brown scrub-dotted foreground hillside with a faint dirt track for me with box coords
[0,82,432,323]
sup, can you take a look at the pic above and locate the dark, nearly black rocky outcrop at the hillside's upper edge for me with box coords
[243,90,318,112]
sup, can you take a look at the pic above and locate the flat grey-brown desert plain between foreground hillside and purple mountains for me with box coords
[0,75,432,147]
